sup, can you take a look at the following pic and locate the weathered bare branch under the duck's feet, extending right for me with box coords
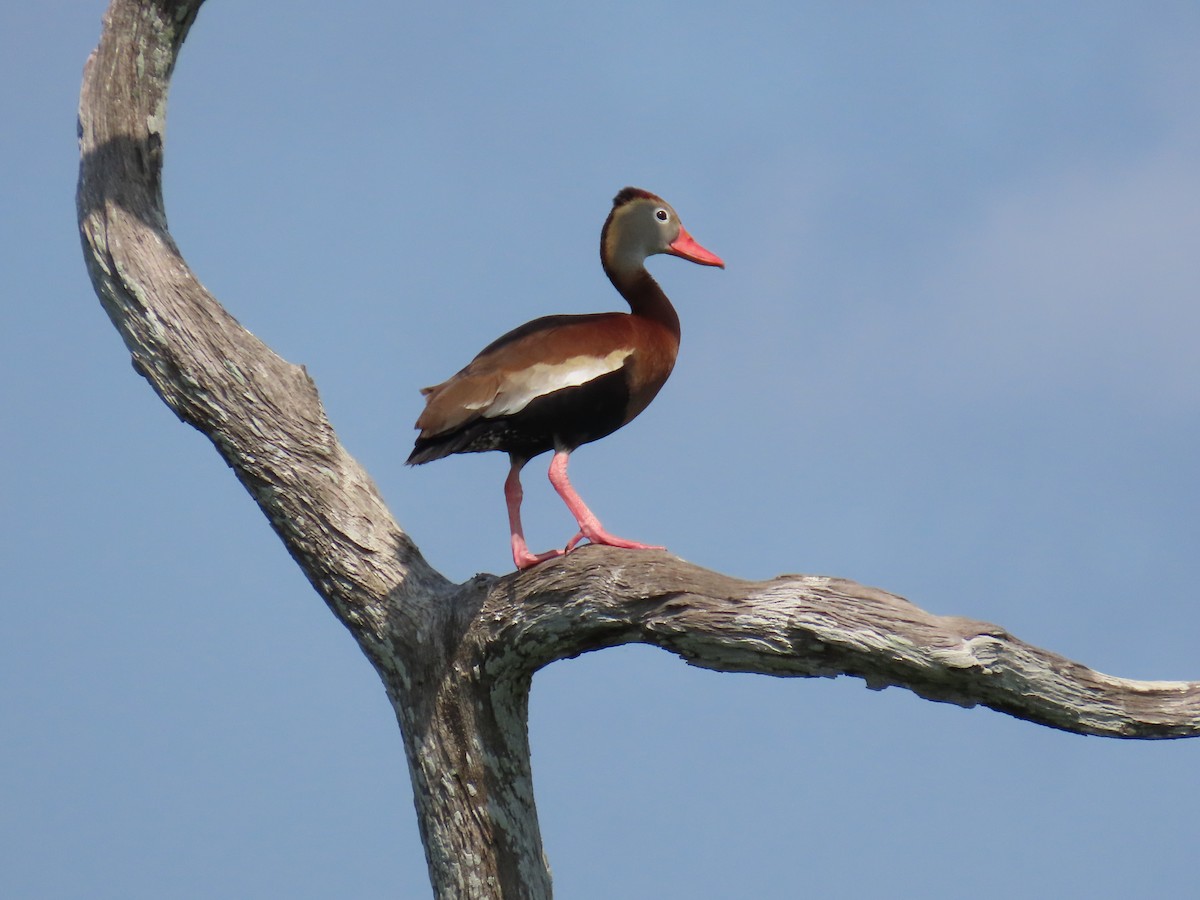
[481,561,1200,738]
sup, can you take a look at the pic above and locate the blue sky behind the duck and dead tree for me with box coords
[7,0,1200,900]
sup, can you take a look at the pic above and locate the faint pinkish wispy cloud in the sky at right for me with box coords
[920,142,1200,408]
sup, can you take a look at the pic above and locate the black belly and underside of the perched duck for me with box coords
[408,368,629,463]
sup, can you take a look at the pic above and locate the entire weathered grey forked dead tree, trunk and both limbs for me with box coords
[77,0,1200,898]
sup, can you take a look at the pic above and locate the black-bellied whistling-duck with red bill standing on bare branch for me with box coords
[408,187,725,569]
